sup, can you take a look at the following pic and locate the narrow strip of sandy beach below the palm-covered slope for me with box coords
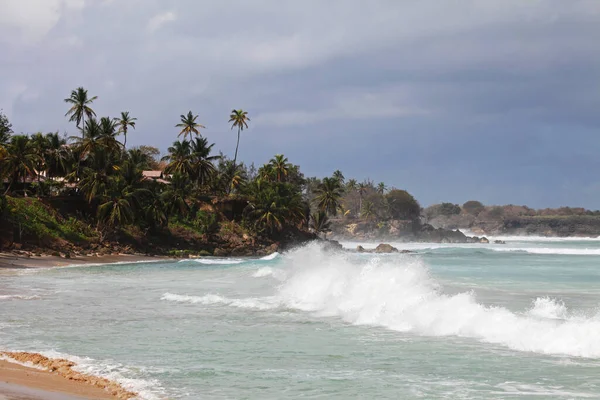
[0,252,174,270]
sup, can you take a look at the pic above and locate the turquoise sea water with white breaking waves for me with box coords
[0,238,600,399]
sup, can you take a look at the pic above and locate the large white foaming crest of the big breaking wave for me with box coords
[278,242,600,358]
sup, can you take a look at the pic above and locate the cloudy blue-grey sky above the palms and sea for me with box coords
[0,0,600,209]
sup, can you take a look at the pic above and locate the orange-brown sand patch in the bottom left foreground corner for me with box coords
[0,352,137,400]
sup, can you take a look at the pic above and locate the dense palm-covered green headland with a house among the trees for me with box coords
[0,87,428,254]
